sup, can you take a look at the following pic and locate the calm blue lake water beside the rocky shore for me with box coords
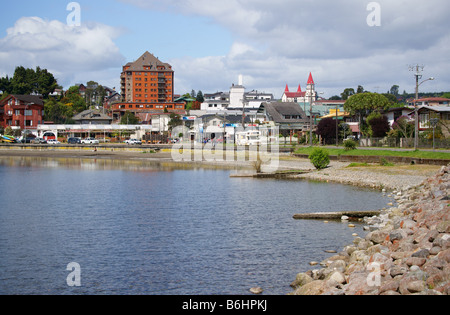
[0,158,388,295]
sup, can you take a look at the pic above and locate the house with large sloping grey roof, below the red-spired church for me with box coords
[262,102,309,133]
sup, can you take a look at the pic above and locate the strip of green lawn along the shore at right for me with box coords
[294,147,450,160]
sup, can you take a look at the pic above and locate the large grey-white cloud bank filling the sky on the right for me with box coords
[113,0,450,97]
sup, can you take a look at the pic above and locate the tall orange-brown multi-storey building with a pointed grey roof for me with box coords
[112,51,185,121]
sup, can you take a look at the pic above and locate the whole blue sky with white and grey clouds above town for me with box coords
[0,0,450,98]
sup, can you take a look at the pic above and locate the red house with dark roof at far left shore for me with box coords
[0,95,44,131]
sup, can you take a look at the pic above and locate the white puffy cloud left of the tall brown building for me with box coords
[0,17,125,87]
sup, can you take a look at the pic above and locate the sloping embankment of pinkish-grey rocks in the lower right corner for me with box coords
[290,166,450,295]
